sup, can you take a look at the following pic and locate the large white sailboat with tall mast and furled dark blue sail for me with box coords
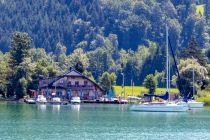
[130,26,189,112]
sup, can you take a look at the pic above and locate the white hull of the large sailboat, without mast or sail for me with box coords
[130,102,189,112]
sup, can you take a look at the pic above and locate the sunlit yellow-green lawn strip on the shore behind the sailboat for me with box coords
[112,86,179,98]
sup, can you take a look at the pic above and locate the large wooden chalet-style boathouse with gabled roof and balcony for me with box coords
[38,68,103,100]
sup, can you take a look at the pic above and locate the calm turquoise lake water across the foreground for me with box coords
[0,103,210,140]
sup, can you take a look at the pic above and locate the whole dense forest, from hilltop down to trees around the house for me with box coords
[0,0,210,98]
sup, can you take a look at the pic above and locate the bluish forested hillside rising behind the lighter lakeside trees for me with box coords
[0,0,210,53]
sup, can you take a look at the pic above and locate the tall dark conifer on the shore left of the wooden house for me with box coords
[7,32,32,99]
